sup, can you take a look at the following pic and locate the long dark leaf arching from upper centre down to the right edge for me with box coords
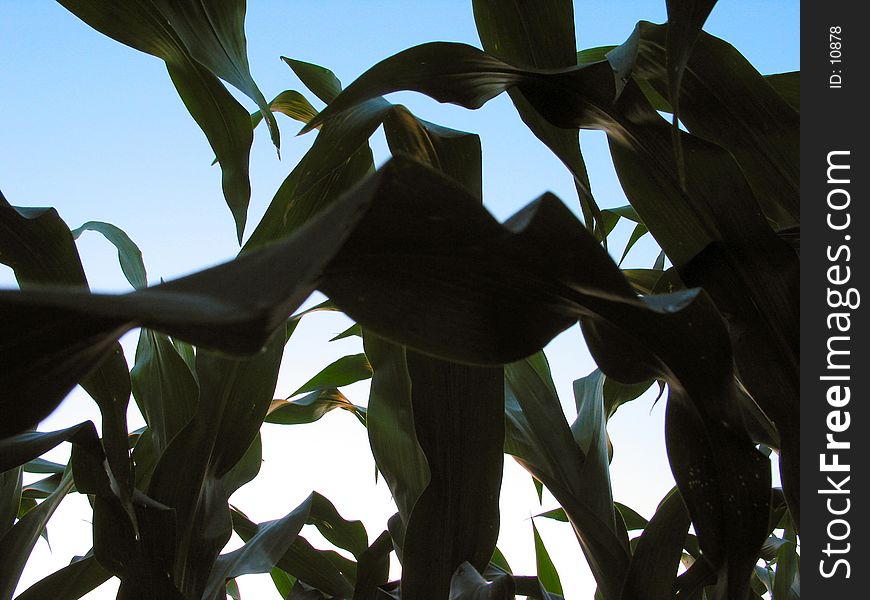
[309,36,799,556]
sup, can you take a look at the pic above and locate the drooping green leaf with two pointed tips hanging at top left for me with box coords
[59,0,280,241]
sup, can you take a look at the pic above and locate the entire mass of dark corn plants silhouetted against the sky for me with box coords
[0,0,800,600]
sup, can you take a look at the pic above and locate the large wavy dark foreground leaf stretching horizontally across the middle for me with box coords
[0,158,767,596]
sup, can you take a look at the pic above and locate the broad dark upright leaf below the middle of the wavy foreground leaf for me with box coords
[394,350,504,599]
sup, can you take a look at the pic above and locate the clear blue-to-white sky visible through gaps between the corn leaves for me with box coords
[0,0,800,600]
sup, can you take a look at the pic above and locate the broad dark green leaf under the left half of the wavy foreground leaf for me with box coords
[149,331,284,596]
